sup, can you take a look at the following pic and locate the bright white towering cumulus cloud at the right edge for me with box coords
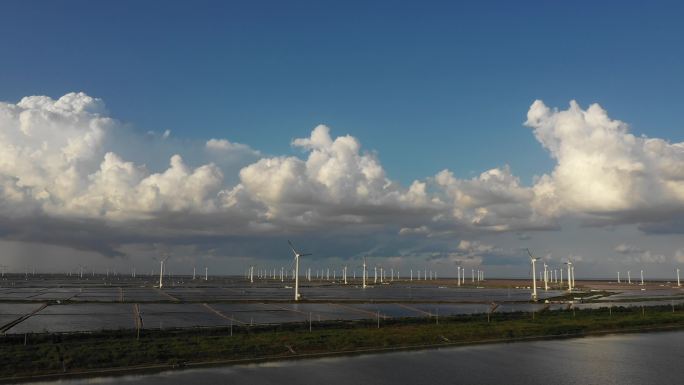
[525,100,684,222]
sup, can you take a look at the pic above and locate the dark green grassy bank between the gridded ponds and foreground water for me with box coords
[0,306,684,381]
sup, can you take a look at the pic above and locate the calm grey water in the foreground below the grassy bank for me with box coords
[26,332,684,385]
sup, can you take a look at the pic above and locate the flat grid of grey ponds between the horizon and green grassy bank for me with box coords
[0,275,684,335]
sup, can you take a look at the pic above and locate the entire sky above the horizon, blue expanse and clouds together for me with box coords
[0,1,684,278]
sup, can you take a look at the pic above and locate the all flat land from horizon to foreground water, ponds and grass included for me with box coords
[0,275,684,381]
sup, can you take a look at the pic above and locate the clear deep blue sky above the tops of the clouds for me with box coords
[0,1,684,183]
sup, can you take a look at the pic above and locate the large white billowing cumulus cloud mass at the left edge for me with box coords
[0,93,254,220]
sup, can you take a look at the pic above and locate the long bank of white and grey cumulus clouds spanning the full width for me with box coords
[0,93,684,264]
